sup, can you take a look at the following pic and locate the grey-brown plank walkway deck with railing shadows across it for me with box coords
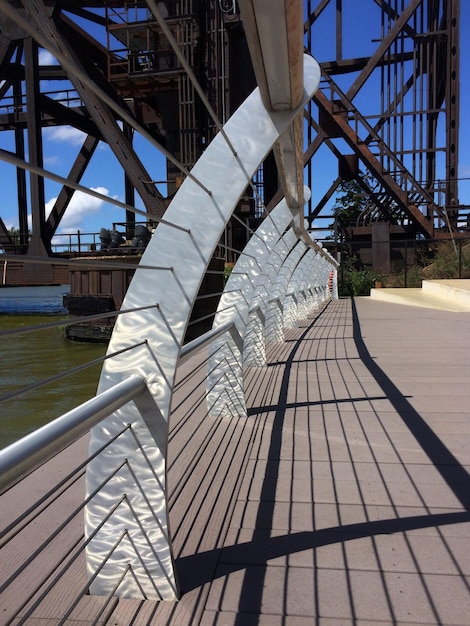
[0,298,470,626]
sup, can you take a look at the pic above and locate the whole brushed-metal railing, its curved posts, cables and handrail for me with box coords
[0,0,337,621]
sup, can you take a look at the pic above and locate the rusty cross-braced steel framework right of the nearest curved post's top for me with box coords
[305,0,462,238]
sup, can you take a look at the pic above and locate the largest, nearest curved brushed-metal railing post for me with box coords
[85,56,320,600]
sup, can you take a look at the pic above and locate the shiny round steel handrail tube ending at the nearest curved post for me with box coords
[0,375,147,495]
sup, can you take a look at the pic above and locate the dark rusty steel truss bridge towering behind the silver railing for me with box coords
[0,0,468,282]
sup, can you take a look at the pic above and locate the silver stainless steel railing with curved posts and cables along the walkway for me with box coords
[0,0,337,612]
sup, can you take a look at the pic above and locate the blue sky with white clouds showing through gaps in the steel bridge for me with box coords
[0,0,470,251]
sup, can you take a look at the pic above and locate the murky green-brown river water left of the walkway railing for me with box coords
[0,285,106,449]
